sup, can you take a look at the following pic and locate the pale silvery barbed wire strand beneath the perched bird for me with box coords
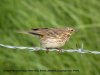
[0,44,100,54]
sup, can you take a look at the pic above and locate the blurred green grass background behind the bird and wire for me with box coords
[0,0,100,75]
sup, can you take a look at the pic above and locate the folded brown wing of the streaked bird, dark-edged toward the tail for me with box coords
[29,28,63,37]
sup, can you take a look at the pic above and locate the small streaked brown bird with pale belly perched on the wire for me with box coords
[18,27,75,53]
